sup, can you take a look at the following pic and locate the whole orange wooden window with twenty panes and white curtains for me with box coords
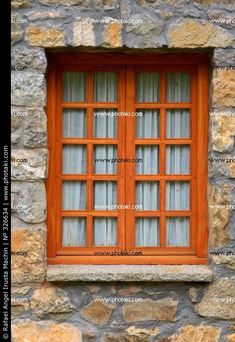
[47,53,208,264]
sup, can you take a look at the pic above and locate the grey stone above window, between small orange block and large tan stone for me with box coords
[124,14,166,48]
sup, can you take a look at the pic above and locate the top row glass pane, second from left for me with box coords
[94,72,117,102]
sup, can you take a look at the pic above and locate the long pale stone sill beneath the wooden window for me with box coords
[47,265,212,282]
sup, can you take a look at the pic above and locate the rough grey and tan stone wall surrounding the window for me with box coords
[11,0,235,342]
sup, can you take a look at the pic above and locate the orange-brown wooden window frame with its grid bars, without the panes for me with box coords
[46,53,209,264]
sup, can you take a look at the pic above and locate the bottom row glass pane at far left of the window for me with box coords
[62,217,86,246]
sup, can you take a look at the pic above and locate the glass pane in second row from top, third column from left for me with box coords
[135,109,159,138]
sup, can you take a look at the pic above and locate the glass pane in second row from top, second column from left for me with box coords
[93,109,117,138]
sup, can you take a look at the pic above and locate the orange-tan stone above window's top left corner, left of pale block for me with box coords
[26,26,66,48]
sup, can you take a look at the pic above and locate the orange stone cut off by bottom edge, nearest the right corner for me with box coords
[169,325,221,342]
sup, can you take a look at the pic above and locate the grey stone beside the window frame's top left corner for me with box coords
[11,46,47,73]
